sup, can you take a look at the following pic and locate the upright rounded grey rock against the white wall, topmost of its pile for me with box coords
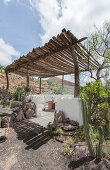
[54,111,65,123]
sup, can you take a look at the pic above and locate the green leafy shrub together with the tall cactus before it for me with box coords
[80,81,110,158]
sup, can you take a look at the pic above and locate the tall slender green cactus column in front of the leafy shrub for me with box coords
[80,94,95,157]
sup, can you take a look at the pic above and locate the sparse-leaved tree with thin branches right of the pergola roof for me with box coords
[86,22,110,80]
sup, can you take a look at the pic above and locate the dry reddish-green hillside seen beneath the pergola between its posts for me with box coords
[0,70,74,94]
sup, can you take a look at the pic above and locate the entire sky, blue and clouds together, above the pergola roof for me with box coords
[0,0,110,82]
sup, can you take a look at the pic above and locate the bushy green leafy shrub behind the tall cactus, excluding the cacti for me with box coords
[82,81,110,132]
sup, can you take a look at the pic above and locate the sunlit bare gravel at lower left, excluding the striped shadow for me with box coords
[0,129,69,170]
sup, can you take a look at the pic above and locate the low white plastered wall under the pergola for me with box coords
[28,94,83,126]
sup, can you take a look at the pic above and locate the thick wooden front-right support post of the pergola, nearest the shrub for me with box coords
[71,46,80,97]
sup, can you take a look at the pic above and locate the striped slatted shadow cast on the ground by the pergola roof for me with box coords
[13,121,50,150]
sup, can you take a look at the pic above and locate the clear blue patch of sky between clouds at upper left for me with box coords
[0,0,42,61]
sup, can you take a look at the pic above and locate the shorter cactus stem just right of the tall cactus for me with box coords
[96,126,104,159]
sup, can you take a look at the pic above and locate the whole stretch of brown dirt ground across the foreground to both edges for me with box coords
[0,124,110,170]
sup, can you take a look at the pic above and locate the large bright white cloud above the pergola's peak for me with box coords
[29,0,110,44]
